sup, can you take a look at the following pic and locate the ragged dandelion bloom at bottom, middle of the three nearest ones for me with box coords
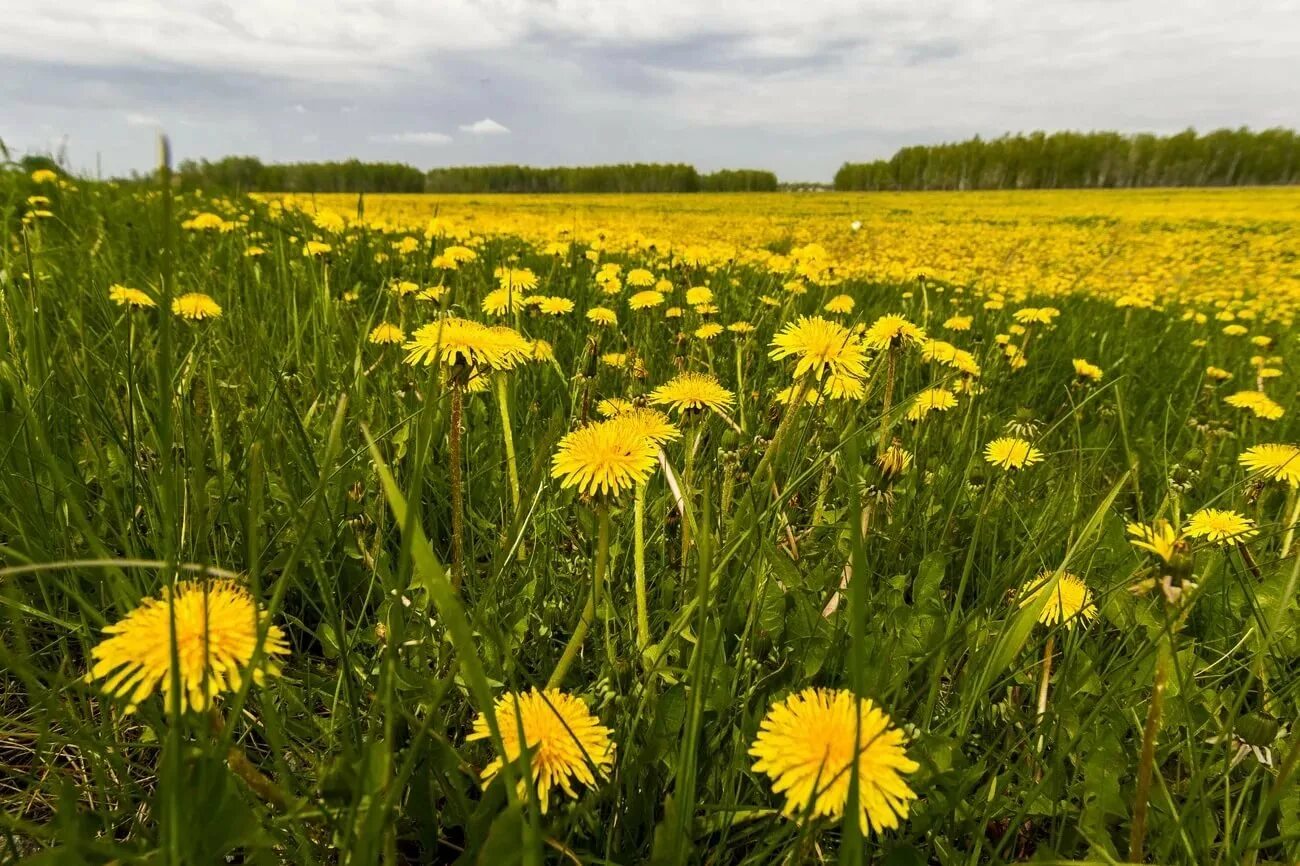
[465,688,614,813]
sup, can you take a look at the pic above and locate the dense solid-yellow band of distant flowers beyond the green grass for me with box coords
[267,187,1300,324]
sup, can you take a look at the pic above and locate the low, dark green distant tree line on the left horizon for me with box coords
[177,156,776,192]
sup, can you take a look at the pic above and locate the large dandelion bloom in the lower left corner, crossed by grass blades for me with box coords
[86,580,289,711]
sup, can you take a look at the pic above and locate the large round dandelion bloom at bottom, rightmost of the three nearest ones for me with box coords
[749,689,919,833]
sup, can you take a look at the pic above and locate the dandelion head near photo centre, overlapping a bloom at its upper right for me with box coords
[551,416,659,495]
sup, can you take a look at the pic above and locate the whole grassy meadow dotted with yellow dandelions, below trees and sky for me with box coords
[0,170,1300,866]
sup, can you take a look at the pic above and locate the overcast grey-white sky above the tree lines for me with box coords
[0,0,1300,181]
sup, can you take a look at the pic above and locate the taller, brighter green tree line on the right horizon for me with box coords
[835,127,1300,190]
